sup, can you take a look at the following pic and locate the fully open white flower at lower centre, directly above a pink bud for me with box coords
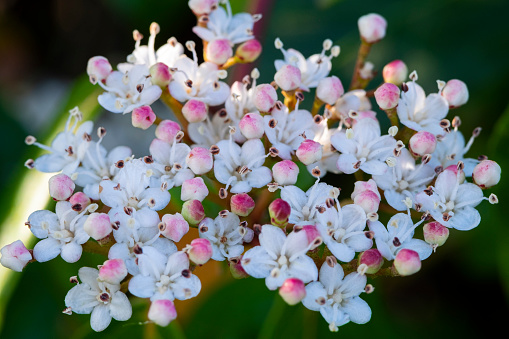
[241,225,318,290]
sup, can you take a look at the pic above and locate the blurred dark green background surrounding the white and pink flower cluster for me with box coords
[0,0,509,338]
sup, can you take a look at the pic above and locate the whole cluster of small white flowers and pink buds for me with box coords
[0,0,501,331]
